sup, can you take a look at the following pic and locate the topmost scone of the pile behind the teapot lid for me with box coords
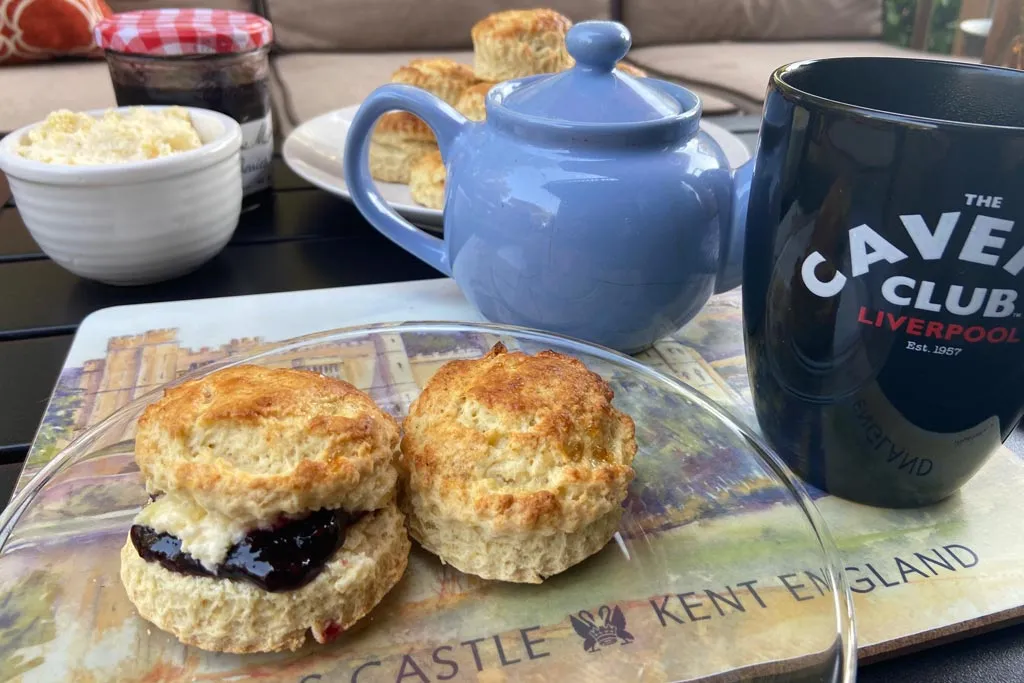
[472,9,572,82]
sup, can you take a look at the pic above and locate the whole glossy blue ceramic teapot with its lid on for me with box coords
[344,22,753,352]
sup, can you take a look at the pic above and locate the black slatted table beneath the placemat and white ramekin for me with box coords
[0,117,1024,683]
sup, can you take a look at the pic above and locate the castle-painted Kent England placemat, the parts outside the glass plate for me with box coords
[18,280,1024,658]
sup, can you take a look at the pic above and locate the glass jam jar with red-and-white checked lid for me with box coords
[95,9,273,195]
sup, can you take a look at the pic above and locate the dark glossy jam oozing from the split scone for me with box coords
[130,510,359,593]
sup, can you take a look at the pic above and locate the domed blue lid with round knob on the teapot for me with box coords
[500,22,688,124]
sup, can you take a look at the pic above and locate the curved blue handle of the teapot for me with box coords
[343,85,467,276]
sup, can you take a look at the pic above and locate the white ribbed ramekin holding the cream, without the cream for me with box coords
[0,106,242,285]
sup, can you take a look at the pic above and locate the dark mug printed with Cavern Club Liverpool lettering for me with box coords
[743,58,1024,507]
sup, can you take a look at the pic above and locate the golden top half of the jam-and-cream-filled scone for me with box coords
[135,366,398,521]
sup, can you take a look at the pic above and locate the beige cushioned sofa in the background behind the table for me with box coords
[0,0,958,134]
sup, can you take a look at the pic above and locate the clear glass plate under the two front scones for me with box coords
[0,323,856,683]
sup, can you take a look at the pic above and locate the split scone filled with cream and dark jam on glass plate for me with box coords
[121,366,410,652]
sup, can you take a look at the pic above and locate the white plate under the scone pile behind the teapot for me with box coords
[282,104,751,229]
